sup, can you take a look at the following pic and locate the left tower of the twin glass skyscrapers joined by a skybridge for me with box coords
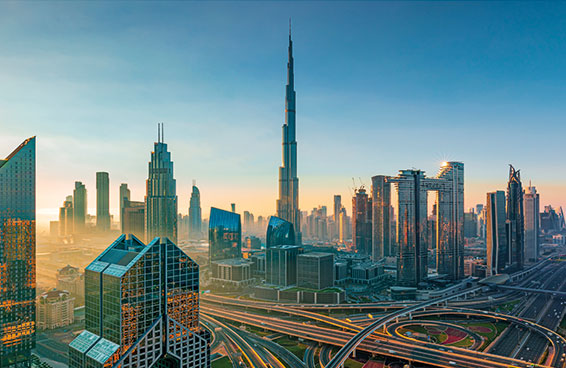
[389,170,428,286]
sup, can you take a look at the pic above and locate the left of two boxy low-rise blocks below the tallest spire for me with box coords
[265,245,301,286]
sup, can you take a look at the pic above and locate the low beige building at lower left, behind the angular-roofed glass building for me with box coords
[36,290,75,330]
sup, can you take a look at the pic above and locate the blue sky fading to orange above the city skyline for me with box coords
[0,1,566,229]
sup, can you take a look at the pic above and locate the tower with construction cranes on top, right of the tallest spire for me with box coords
[352,186,372,256]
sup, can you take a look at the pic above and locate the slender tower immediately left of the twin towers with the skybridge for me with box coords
[371,175,394,262]
